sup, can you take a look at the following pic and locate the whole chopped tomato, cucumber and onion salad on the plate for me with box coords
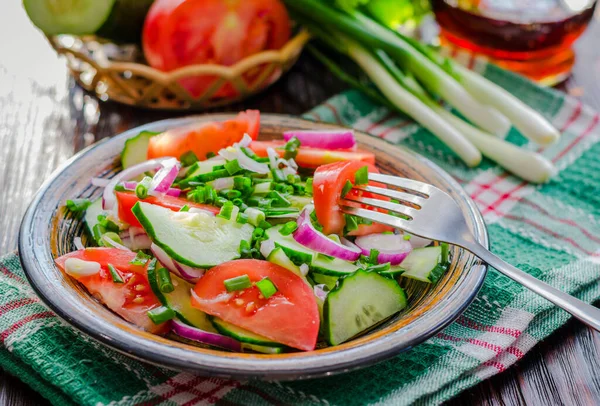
[56,110,448,354]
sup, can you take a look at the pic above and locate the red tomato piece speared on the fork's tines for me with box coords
[313,161,392,235]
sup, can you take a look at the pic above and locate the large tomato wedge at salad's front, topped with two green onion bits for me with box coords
[192,259,319,351]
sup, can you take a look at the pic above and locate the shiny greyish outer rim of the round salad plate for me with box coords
[18,114,488,380]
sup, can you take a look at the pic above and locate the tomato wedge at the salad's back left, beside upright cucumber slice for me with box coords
[148,110,260,160]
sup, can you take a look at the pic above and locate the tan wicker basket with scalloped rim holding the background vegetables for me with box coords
[48,31,310,110]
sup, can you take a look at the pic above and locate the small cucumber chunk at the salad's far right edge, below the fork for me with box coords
[400,245,446,283]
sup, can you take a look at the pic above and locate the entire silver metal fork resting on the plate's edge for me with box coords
[340,173,600,331]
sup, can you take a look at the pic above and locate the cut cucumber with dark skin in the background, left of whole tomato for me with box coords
[23,0,154,42]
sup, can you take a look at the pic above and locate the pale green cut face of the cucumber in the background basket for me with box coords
[23,0,115,35]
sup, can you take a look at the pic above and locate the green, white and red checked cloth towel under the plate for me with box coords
[0,60,600,405]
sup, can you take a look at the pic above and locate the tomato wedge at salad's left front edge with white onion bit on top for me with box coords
[55,248,168,333]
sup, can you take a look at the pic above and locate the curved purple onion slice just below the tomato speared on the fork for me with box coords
[293,206,361,262]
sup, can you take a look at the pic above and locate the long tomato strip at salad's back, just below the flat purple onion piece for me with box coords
[250,141,375,168]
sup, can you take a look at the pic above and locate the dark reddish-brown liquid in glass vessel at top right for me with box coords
[432,0,596,61]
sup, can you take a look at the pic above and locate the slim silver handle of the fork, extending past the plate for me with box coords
[465,243,600,331]
